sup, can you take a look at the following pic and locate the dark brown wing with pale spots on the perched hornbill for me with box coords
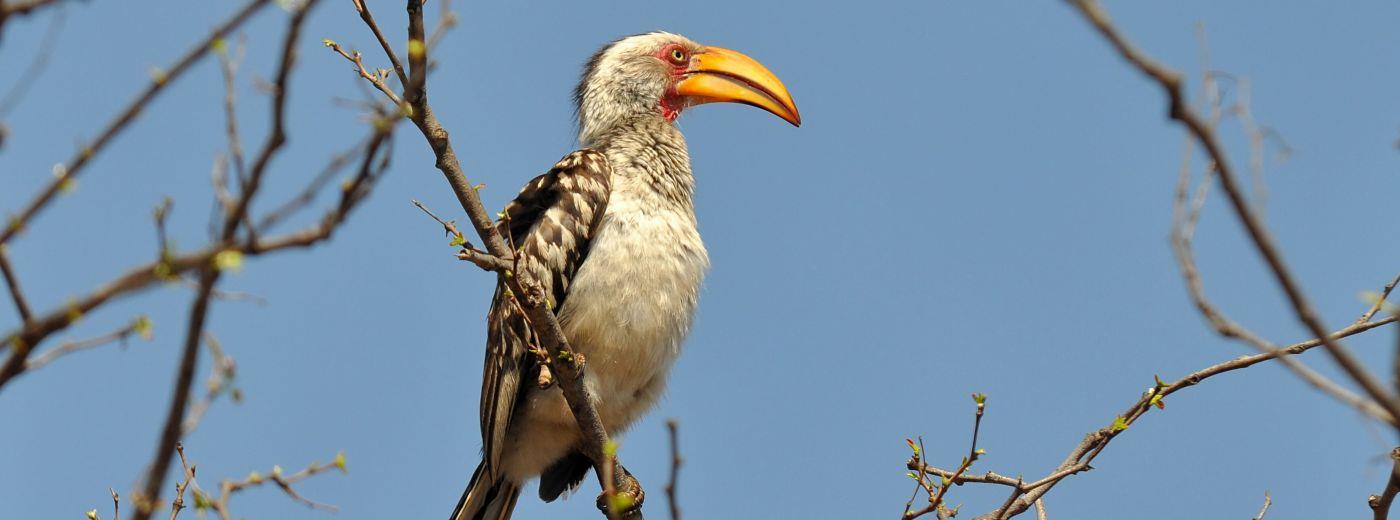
[482,150,612,471]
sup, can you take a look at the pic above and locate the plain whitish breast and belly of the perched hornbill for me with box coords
[559,192,710,430]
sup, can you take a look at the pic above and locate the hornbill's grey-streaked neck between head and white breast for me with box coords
[582,115,694,210]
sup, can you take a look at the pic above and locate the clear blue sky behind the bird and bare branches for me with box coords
[0,0,1400,520]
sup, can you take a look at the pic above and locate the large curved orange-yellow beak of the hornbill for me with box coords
[676,46,802,126]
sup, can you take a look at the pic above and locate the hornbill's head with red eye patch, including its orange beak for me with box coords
[574,32,802,143]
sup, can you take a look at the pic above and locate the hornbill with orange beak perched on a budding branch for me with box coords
[452,32,802,520]
